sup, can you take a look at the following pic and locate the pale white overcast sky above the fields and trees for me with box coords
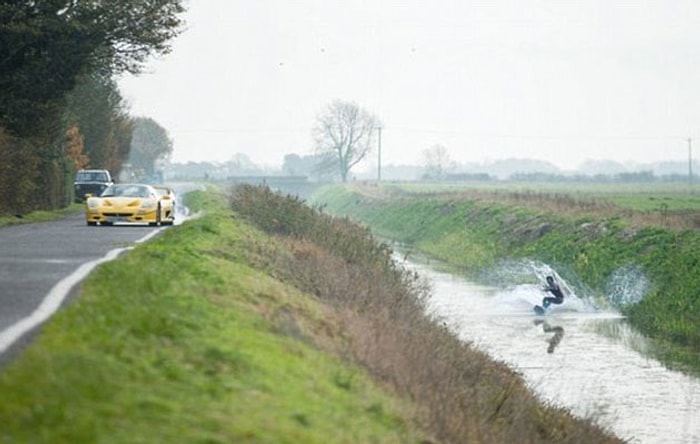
[120,0,700,169]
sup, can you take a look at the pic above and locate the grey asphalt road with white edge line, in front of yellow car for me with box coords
[0,213,164,362]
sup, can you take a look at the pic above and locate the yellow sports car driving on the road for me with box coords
[85,183,175,225]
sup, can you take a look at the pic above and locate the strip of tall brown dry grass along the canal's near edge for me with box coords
[230,185,619,443]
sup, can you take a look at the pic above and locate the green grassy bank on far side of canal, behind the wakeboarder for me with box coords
[313,186,700,369]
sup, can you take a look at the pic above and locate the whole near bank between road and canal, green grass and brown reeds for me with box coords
[0,188,617,443]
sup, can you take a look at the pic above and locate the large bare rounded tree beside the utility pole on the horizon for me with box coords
[313,100,380,182]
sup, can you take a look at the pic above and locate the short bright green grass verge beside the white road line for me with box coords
[0,193,423,444]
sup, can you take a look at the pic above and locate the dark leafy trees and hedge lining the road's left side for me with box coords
[0,0,184,214]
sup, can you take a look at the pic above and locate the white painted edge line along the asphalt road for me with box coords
[0,228,163,354]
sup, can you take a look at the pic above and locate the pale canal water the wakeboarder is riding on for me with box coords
[406,263,700,444]
